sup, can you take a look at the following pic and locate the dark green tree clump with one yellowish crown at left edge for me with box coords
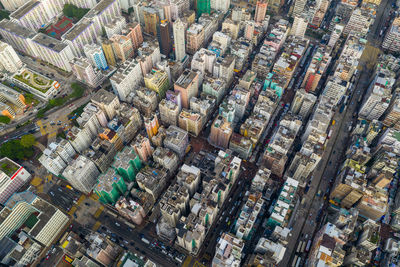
[0,134,36,160]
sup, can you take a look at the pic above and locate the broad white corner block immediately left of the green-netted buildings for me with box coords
[62,155,100,194]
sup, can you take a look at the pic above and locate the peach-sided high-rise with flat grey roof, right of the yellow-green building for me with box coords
[174,69,199,109]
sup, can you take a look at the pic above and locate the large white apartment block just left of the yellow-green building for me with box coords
[110,59,143,101]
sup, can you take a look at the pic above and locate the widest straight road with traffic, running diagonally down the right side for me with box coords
[279,0,389,267]
